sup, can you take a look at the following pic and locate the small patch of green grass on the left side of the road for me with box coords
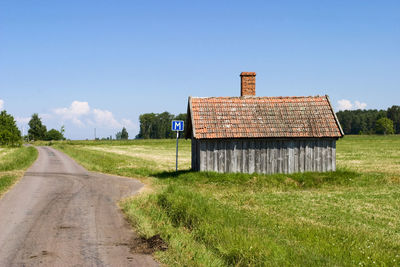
[0,146,38,197]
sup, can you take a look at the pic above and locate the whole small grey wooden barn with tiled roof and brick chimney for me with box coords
[186,72,344,174]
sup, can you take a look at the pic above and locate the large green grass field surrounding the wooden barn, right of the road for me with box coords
[55,136,400,266]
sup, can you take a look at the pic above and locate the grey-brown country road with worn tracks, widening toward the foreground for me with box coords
[0,147,157,266]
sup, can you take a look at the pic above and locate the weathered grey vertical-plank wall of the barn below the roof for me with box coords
[192,139,336,174]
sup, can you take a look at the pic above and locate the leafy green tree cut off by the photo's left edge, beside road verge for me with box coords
[0,110,22,146]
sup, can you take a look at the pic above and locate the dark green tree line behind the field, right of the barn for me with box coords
[336,106,400,134]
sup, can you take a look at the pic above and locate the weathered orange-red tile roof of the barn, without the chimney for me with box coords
[186,96,343,139]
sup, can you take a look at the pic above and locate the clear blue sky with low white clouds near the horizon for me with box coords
[0,0,400,139]
